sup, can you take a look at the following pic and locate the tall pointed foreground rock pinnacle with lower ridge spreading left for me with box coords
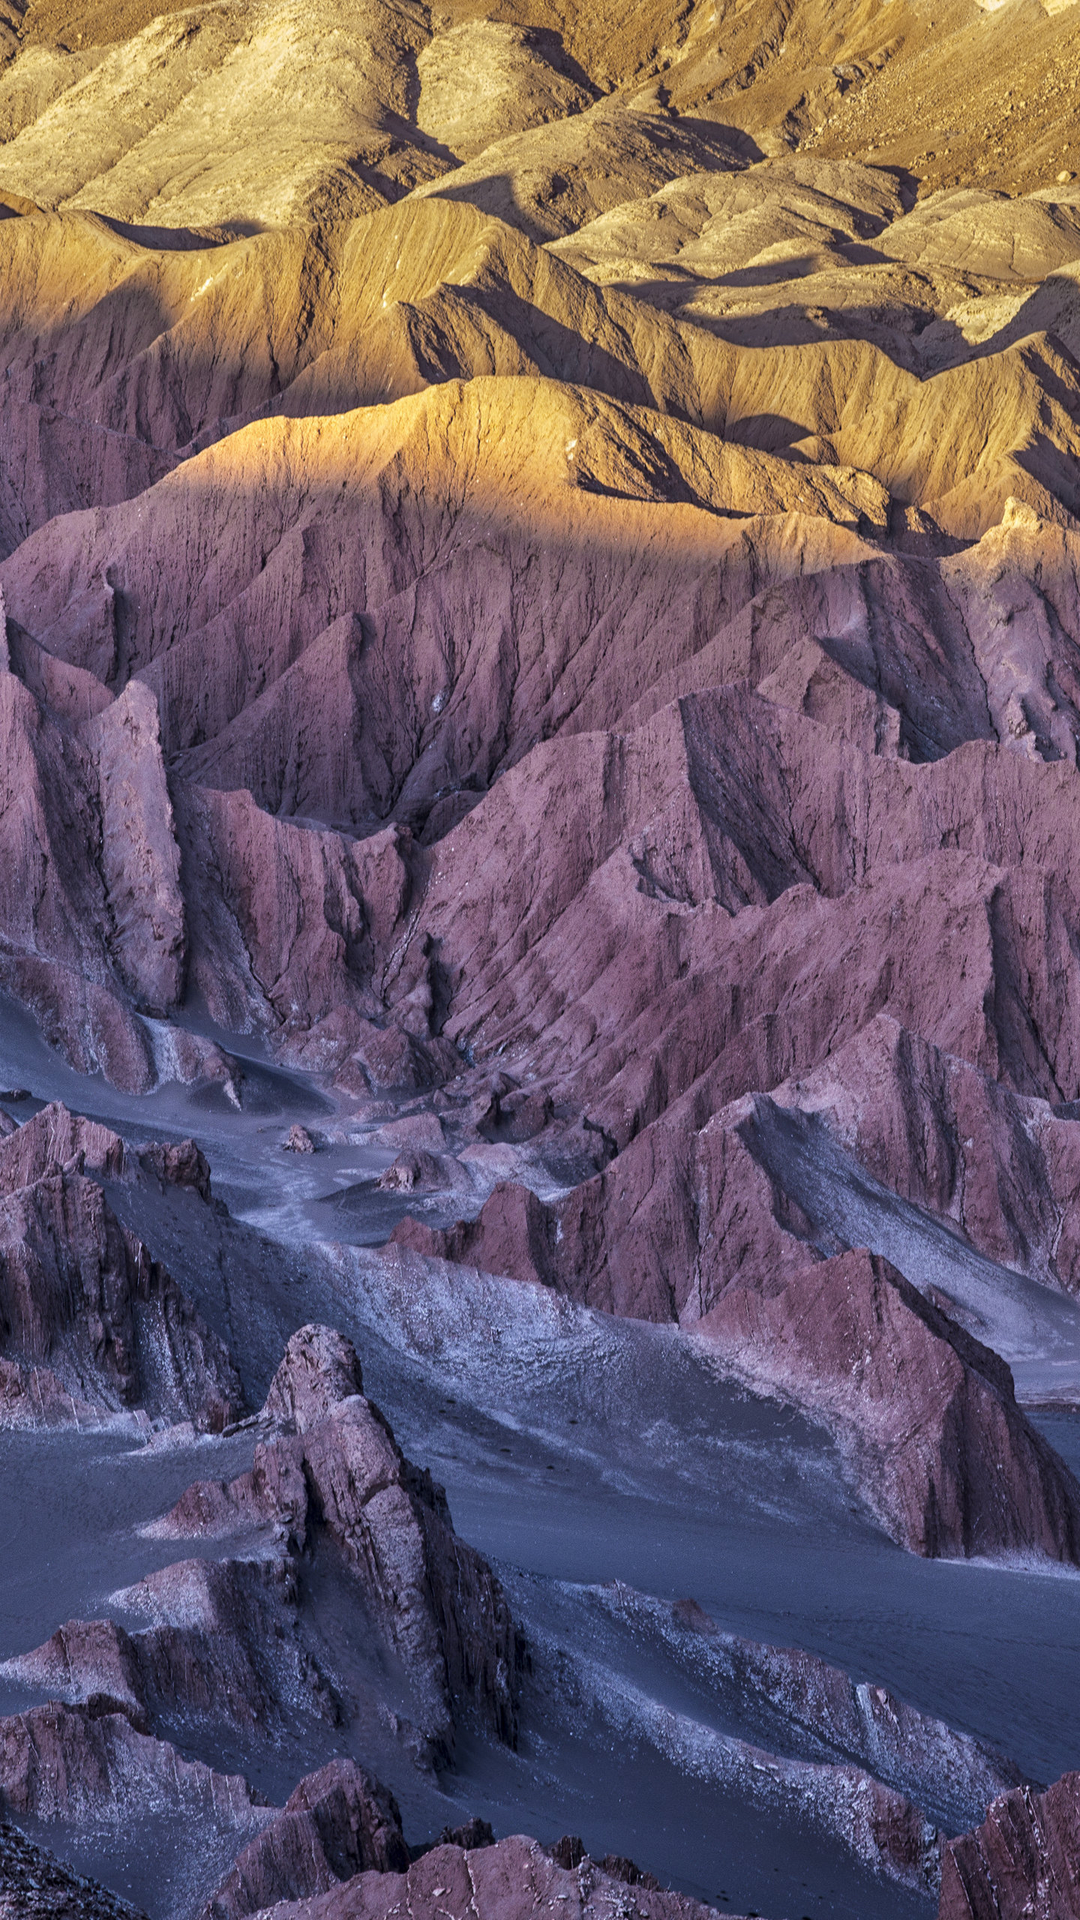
[0,1327,525,1774]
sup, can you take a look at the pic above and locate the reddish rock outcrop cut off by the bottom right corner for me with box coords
[938,1774,1080,1920]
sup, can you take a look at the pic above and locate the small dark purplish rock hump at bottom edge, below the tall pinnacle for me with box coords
[202,1761,409,1920]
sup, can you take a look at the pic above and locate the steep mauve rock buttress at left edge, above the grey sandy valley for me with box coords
[0,641,227,1092]
